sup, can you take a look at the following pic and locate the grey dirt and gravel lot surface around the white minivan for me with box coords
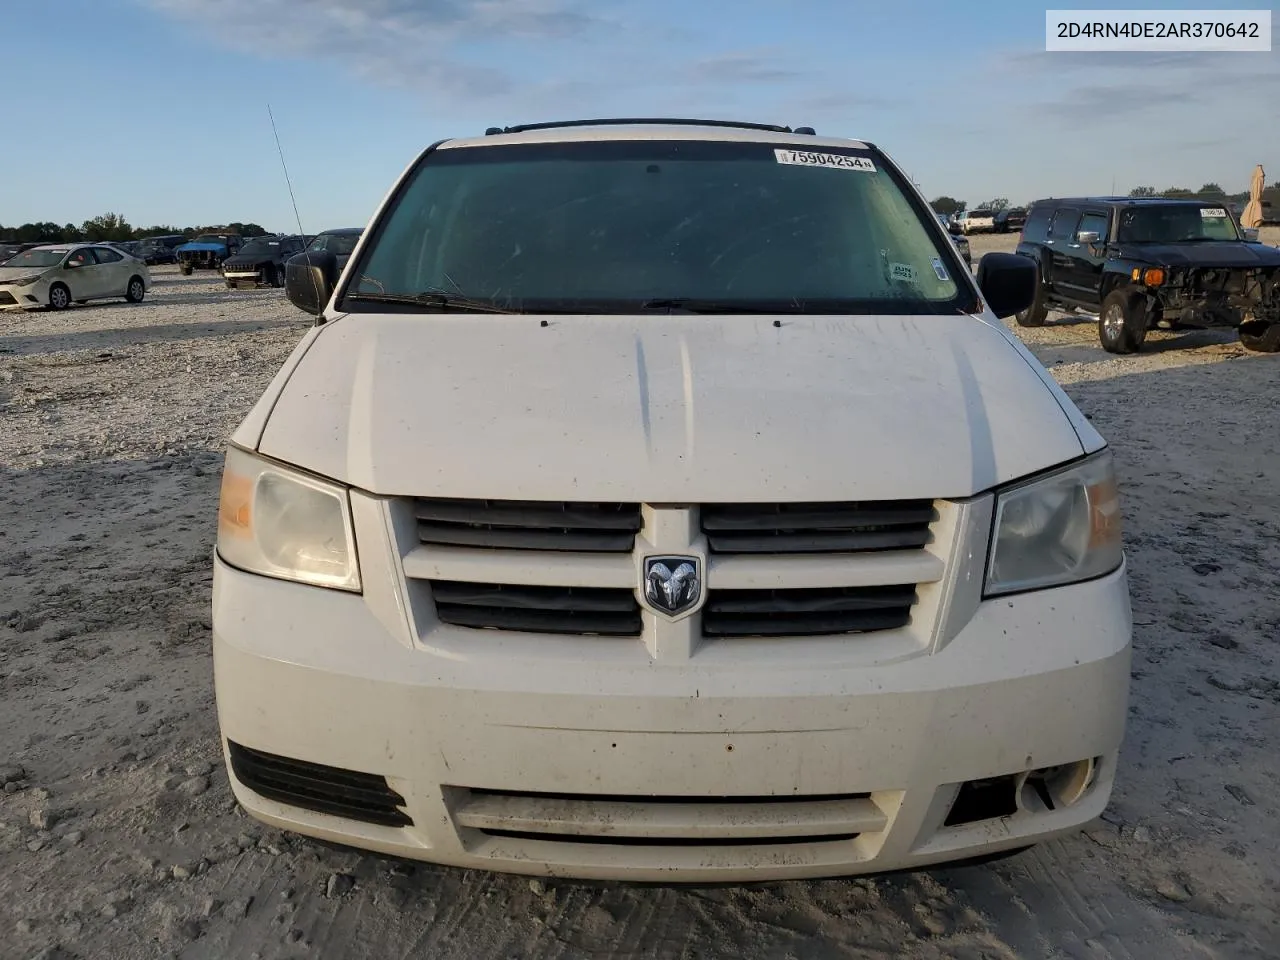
[0,244,1280,960]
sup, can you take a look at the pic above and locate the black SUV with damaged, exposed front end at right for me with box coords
[1016,197,1280,353]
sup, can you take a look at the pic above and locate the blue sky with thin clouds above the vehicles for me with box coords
[0,0,1280,232]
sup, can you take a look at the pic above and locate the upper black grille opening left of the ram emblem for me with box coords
[413,498,641,553]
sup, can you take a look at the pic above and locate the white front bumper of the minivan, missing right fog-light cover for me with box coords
[214,545,1130,882]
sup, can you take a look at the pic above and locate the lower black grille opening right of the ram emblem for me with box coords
[703,584,916,637]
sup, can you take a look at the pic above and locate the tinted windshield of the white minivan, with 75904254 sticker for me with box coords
[339,140,978,314]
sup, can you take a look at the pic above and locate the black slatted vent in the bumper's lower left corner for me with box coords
[229,742,413,827]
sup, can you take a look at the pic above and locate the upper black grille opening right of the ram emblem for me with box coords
[701,500,937,554]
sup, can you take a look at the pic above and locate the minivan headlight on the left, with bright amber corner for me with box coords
[218,448,360,591]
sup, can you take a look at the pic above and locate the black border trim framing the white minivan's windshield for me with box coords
[333,138,982,315]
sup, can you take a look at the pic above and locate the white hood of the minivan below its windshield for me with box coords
[259,314,1084,503]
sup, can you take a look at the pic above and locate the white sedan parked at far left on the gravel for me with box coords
[0,243,151,310]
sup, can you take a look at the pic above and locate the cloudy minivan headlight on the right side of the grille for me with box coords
[986,449,1124,596]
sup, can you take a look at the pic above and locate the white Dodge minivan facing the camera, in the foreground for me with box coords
[214,120,1130,882]
